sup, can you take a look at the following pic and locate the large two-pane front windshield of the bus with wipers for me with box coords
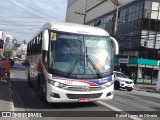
[49,32,113,76]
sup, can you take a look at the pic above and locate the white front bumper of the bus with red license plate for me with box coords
[46,83,114,103]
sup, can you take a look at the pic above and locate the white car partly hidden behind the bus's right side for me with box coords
[113,71,134,91]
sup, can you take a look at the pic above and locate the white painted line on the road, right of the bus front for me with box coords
[96,101,142,120]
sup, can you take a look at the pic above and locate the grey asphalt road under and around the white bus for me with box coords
[11,62,160,120]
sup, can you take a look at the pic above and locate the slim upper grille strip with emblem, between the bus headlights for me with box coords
[64,86,104,91]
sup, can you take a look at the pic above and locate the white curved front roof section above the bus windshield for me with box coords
[42,22,109,36]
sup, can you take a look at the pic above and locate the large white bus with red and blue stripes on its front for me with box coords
[26,23,119,102]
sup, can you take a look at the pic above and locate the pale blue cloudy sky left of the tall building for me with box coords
[0,0,68,41]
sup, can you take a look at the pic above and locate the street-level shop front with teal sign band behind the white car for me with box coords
[115,58,160,85]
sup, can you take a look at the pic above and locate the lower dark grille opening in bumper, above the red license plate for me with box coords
[66,93,102,99]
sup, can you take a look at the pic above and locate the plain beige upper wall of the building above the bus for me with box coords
[65,0,133,23]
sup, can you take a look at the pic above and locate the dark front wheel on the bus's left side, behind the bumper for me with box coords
[38,77,46,101]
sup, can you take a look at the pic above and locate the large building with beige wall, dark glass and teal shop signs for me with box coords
[66,0,160,83]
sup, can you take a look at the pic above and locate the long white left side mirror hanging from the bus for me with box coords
[42,30,49,50]
